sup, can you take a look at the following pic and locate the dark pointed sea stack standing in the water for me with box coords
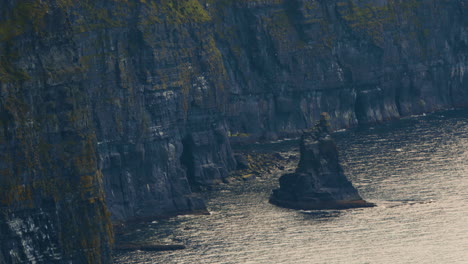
[270,113,375,210]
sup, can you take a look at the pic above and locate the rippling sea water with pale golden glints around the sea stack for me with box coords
[116,110,468,264]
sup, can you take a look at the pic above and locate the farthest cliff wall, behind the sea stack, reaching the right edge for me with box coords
[209,0,468,137]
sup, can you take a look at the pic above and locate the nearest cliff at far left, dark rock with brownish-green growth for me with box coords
[0,1,112,263]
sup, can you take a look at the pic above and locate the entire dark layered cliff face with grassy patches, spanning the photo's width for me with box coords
[0,0,468,263]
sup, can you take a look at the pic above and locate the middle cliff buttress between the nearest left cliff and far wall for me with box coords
[63,1,235,220]
